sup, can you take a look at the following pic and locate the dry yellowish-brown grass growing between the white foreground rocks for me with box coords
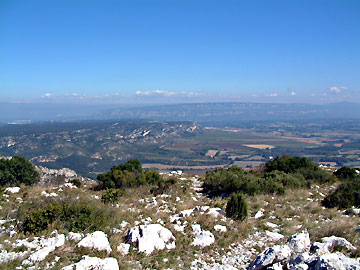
[0,170,360,269]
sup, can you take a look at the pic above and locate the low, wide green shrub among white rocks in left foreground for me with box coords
[22,202,107,233]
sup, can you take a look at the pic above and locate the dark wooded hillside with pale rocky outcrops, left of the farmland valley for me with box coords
[0,120,202,174]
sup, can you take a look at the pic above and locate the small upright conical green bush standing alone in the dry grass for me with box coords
[226,193,248,221]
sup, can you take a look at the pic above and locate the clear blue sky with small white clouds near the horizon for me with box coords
[0,0,360,103]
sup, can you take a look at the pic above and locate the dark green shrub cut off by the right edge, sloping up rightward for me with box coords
[321,176,360,209]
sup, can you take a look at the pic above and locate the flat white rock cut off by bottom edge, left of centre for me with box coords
[62,256,119,270]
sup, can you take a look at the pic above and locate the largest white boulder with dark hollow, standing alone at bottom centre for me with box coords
[125,224,175,255]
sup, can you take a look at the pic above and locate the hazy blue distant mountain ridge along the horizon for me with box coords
[0,102,360,123]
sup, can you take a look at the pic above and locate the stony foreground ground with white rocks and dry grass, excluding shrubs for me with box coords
[0,168,360,270]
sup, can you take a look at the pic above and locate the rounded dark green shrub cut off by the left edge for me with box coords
[0,156,39,185]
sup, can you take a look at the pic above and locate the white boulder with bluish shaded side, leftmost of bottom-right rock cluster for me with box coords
[249,245,292,270]
